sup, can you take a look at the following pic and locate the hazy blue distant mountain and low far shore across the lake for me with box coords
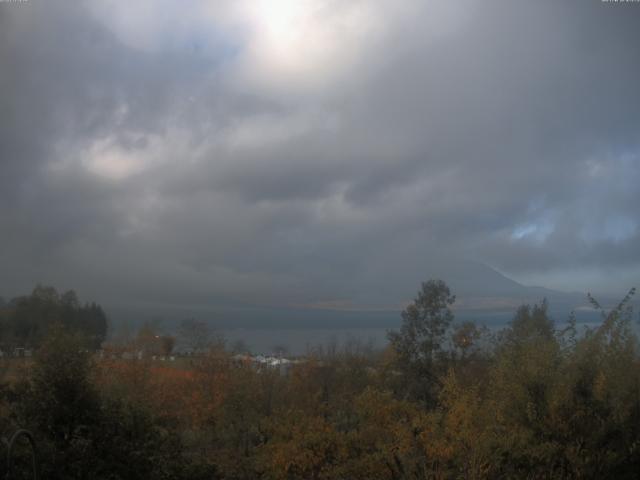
[108,260,626,329]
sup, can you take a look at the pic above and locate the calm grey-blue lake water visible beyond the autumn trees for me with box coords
[112,309,624,355]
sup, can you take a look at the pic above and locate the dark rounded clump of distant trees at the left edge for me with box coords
[0,285,107,349]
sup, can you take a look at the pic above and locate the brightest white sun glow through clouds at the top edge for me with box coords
[90,0,389,90]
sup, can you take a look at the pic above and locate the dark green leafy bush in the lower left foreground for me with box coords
[7,329,196,480]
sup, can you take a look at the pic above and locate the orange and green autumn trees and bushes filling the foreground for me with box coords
[0,281,640,480]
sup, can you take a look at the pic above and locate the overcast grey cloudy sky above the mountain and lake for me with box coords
[0,0,640,308]
